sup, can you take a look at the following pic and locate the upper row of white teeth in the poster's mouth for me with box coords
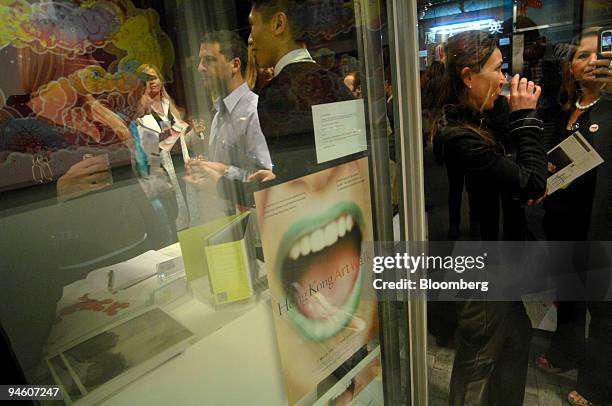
[289,214,355,261]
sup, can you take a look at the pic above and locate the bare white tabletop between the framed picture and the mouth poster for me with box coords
[103,299,287,406]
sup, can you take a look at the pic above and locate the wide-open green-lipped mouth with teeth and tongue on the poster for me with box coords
[276,202,364,341]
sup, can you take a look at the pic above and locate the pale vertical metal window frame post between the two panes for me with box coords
[387,0,429,406]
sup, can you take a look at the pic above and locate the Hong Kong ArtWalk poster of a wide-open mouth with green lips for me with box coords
[255,158,378,405]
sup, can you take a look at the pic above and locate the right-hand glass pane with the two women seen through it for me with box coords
[417,0,612,405]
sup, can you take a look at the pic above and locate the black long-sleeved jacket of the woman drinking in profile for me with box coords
[433,106,547,240]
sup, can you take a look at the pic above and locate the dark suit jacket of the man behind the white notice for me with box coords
[257,62,354,183]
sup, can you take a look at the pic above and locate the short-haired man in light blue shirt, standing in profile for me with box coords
[187,30,272,218]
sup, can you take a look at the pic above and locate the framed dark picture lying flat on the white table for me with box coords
[46,307,194,405]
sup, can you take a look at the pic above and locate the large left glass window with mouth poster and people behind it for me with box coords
[0,0,399,405]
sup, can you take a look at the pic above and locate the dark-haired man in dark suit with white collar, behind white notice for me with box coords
[249,0,353,181]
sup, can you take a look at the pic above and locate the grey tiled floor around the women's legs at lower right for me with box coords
[427,333,576,406]
